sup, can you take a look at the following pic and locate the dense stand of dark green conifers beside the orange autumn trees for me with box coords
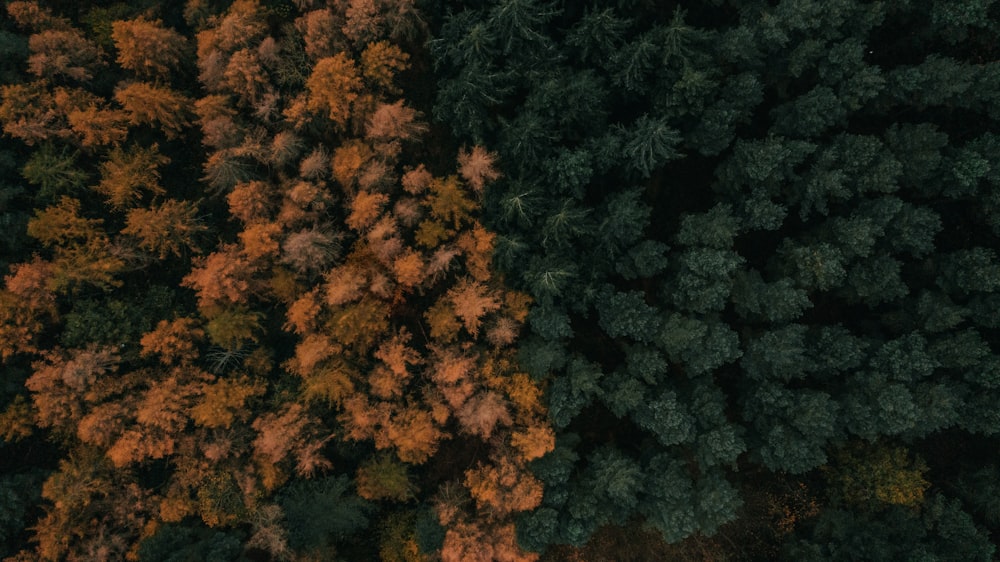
[431,0,1000,559]
